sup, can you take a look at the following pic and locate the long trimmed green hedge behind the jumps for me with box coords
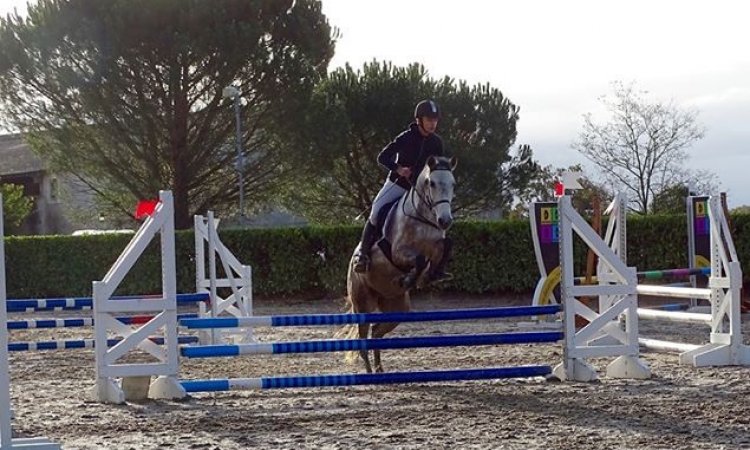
[6,215,750,298]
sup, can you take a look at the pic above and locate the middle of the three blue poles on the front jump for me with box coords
[180,331,563,358]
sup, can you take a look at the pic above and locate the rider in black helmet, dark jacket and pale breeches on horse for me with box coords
[354,100,451,281]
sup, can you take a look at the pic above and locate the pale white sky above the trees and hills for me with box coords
[5,0,750,207]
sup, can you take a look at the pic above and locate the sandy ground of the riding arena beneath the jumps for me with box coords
[5,296,750,450]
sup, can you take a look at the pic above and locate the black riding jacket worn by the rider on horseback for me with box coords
[378,123,445,189]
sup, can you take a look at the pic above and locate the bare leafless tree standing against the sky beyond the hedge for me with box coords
[573,82,703,214]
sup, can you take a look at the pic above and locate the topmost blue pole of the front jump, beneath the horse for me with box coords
[180,305,561,329]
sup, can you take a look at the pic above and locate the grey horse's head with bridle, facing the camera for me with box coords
[415,156,458,230]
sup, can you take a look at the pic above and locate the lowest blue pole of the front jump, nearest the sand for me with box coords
[181,366,552,392]
